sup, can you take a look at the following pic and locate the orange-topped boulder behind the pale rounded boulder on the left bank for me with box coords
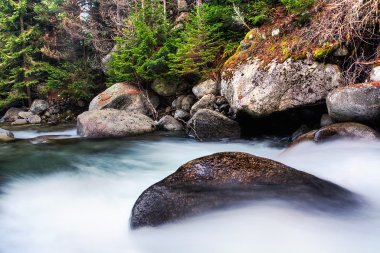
[89,83,159,115]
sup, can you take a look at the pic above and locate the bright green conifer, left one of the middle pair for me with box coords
[107,1,171,83]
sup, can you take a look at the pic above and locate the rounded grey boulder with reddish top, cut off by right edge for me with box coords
[326,82,380,122]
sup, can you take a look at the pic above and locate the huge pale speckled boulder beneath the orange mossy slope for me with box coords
[221,59,343,117]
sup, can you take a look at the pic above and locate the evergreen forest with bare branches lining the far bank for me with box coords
[0,0,314,112]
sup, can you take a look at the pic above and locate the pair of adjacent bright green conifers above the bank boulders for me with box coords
[107,1,241,84]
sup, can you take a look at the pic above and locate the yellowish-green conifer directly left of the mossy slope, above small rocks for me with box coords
[169,4,231,79]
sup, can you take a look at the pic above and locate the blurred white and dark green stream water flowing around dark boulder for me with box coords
[0,129,380,253]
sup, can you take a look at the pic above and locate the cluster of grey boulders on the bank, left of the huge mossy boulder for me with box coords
[77,79,240,140]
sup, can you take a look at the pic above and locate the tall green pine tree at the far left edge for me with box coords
[0,0,43,109]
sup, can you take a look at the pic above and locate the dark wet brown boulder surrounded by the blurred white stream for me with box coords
[130,152,359,229]
